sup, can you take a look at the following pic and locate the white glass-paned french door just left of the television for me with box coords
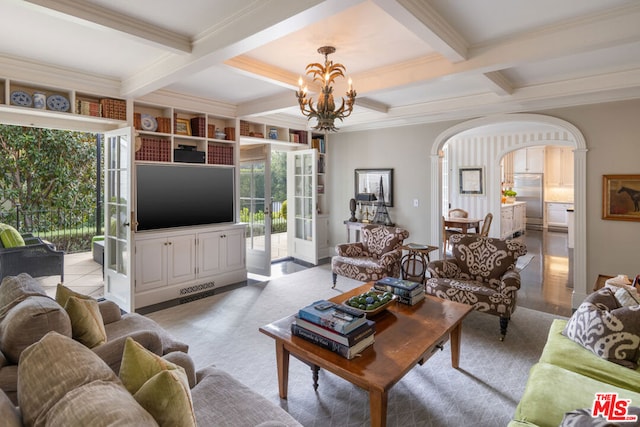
[104,128,135,312]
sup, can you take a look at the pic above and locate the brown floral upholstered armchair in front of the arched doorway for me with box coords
[425,234,527,341]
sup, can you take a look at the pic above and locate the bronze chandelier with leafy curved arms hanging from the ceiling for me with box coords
[296,46,356,132]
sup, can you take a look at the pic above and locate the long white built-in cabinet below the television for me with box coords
[135,224,247,308]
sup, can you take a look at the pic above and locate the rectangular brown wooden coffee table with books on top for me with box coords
[260,282,472,426]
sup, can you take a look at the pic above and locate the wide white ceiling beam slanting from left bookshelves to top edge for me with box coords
[122,0,364,97]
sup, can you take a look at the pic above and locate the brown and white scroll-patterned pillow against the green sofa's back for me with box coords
[562,288,640,369]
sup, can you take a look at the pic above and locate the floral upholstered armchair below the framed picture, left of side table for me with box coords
[331,225,409,288]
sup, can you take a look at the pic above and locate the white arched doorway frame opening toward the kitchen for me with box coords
[431,114,588,308]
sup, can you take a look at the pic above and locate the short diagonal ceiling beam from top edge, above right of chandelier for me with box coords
[374,0,468,62]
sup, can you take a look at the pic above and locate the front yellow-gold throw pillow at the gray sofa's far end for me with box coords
[64,297,107,348]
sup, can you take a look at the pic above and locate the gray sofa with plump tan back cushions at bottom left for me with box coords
[0,274,300,427]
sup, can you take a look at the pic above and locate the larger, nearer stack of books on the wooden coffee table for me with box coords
[291,300,375,359]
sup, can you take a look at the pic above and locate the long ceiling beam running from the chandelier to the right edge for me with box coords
[352,3,640,94]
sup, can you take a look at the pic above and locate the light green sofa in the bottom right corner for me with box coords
[509,319,640,427]
